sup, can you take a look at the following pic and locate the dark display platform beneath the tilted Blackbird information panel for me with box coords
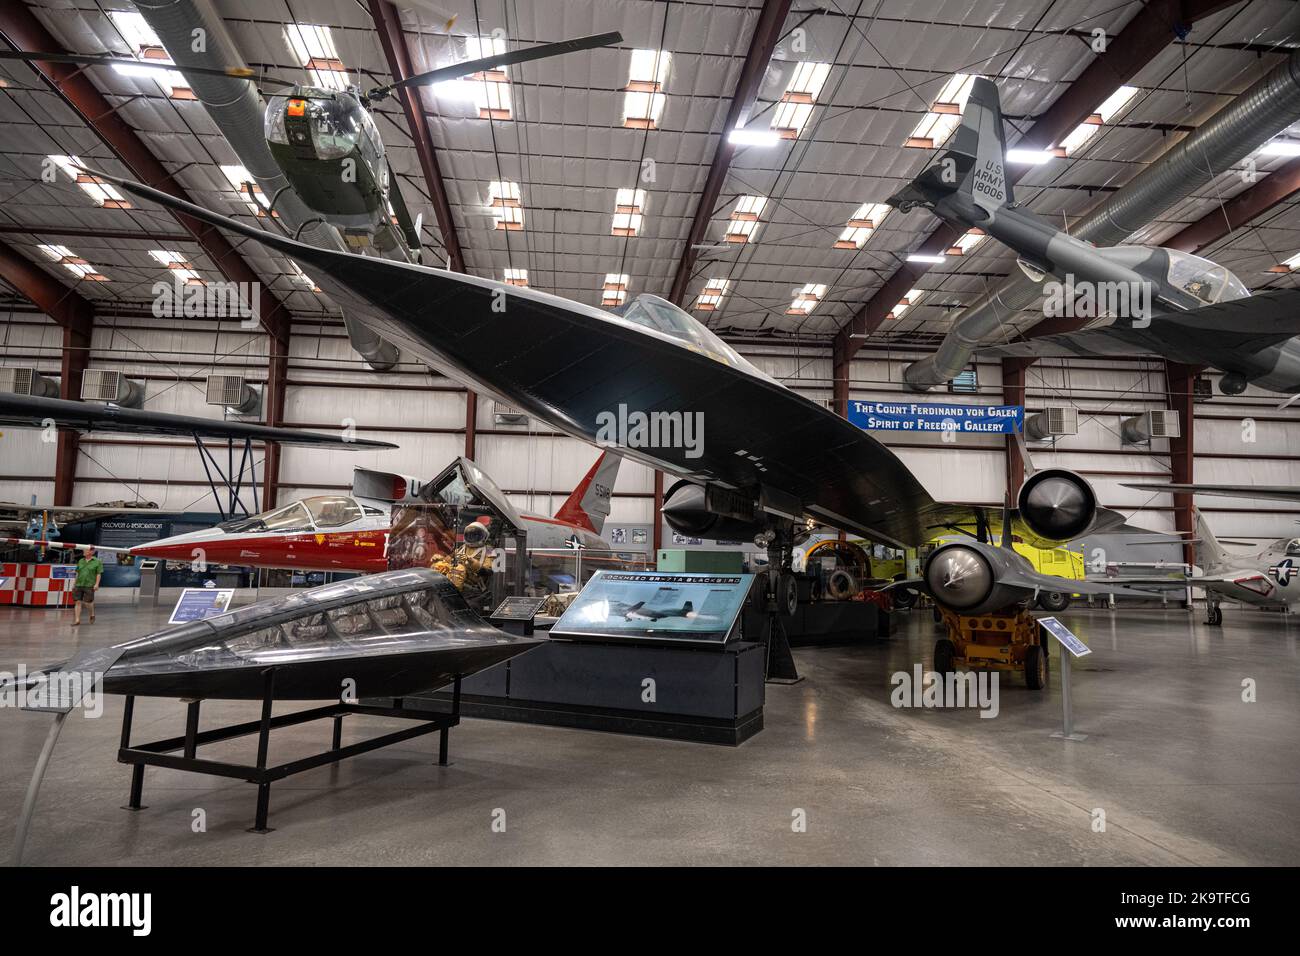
[406,640,763,747]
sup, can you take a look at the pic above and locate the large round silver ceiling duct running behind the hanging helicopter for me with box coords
[135,0,399,372]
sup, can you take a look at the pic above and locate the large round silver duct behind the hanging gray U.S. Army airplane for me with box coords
[904,51,1300,392]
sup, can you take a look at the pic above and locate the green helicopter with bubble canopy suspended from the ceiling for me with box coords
[0,33,623,261]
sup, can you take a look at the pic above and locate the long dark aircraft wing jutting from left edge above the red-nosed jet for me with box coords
[0,393,397,451]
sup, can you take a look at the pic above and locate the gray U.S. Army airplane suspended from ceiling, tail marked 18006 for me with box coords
[888,77,1300,395]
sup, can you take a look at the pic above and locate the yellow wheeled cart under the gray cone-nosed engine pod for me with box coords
[935,606,1048,691]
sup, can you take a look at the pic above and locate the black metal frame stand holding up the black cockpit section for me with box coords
[117,667,460,834]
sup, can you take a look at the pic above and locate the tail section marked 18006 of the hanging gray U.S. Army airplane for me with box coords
[887,77,1015,212]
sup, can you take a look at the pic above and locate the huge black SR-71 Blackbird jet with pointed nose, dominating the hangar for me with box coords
[87,170,1123,614]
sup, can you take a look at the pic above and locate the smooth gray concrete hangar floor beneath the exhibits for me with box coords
[0,601,1300,865]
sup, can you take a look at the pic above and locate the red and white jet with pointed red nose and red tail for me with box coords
[130,451,623,572]
